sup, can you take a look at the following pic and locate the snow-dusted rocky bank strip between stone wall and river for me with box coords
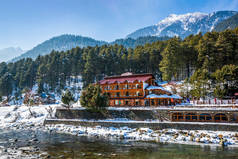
[46,124,238,147]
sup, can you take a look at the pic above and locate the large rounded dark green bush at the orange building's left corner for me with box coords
[80,84,108,111]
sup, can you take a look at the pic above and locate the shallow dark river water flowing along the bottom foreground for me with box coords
[0,130,238,159]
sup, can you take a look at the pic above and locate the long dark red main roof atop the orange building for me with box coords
[99,73,154,84]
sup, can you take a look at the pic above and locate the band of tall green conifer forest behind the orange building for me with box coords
[0,28,238,100]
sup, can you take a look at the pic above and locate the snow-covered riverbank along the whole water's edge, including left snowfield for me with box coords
[0,105,238,147]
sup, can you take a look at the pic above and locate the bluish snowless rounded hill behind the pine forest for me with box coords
[11,35,169,62]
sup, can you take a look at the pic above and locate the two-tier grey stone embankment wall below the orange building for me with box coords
[44,108,238,131]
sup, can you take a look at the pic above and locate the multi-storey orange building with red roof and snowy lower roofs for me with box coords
[99,73,182,106]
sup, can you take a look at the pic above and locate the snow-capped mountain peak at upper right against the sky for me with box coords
[127,11,238,39]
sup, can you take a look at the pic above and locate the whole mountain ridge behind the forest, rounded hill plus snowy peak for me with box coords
[10,11,238,62]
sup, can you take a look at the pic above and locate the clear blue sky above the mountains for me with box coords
[0,0,238,50]
